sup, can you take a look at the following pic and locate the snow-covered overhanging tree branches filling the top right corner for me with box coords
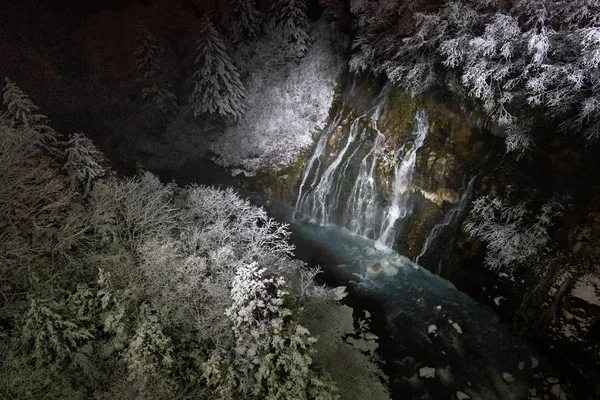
[350,0,600,151]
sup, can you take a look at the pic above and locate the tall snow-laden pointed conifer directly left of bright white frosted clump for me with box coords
[190,16,247,120]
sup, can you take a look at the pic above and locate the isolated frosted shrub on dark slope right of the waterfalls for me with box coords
[465,195,567,275]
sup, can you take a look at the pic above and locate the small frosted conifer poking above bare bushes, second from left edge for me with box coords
[63,133,106,194]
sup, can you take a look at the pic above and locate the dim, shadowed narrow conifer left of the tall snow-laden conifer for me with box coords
[135,25,178,116]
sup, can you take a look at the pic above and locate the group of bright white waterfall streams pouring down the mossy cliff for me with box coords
[294,84,428,247]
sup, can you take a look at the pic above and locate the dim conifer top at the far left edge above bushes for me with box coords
[2,78,56,139]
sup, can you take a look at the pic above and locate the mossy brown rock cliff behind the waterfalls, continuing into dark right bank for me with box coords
[249,79,600,399]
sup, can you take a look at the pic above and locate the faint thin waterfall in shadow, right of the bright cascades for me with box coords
[415,175,478,275]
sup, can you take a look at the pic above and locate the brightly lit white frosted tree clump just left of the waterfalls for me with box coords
[210,22,343,170]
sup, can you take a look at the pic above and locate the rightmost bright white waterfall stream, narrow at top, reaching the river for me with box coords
[377,111,429,248]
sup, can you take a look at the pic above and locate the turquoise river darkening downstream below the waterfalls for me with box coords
[290,220,551,400]
